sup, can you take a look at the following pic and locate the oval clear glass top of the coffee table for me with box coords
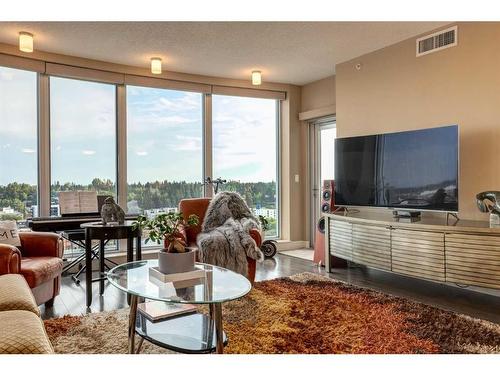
[108,260,252,304]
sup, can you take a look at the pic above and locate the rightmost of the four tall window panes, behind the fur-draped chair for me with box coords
[212,95,279,237]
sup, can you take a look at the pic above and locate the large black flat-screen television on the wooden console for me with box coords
[334,125,458,212]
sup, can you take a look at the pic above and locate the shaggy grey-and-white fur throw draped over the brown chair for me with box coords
[196,192,264,276]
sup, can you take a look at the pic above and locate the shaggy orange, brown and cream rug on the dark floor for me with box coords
[45,273,500,354]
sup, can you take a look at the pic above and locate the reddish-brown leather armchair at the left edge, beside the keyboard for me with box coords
[0,232,63,307]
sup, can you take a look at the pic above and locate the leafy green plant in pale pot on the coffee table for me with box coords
[134,212,200,274]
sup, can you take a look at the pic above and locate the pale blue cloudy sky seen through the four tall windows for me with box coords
[0,67,276,185]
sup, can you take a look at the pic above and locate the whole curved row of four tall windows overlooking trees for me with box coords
[0,62,284,246]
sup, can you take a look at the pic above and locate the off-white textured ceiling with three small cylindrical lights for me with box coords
[0,22,448,85]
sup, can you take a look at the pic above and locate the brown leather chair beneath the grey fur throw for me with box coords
[179,198,262,284]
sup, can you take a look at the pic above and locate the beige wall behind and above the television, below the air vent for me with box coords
[336,23,500,220]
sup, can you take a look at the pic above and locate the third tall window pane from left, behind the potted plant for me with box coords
[127,86,203,217]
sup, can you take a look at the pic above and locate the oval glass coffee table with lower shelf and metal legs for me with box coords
[108,260,252,354]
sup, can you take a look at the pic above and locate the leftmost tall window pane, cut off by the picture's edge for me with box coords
[0,67,38,223]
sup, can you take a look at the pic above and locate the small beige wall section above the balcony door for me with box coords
[300,76,335,112]
